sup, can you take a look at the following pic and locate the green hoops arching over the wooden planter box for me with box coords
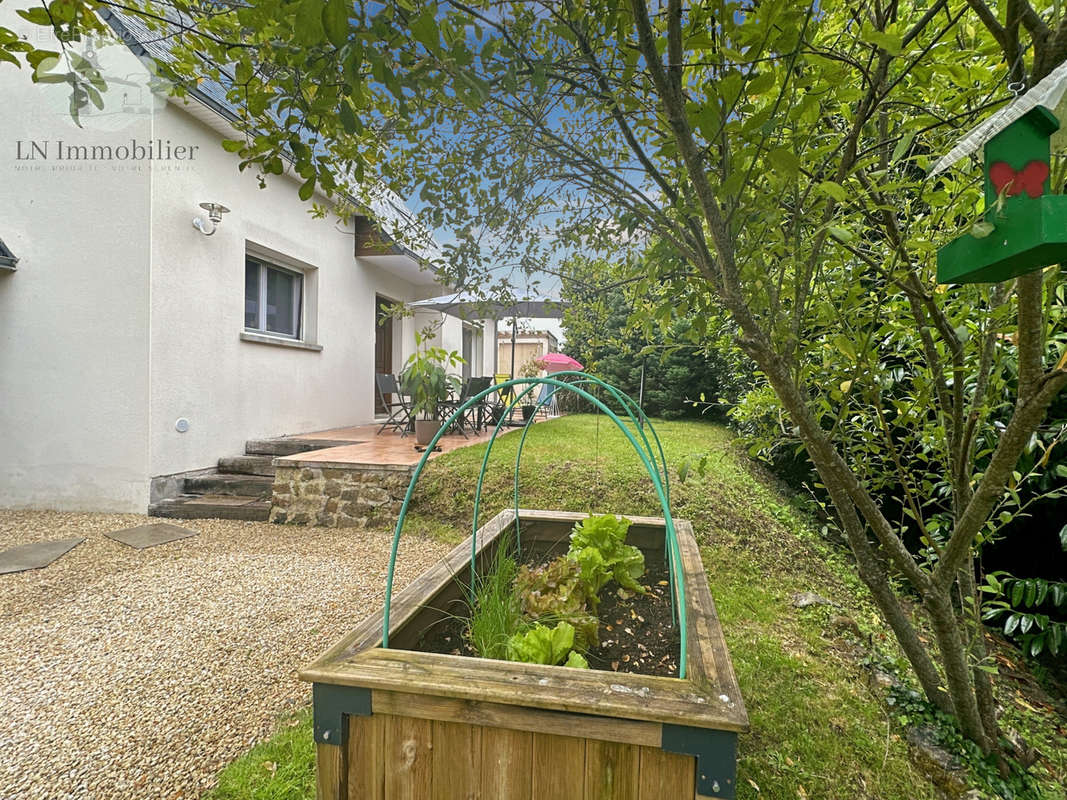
[382,372,688,678]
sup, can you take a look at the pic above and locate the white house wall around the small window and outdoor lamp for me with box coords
[149,99,440,476]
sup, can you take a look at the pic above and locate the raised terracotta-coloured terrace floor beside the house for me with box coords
[275,419,543,467]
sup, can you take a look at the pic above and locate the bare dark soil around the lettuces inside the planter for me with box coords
[416,556,681,677]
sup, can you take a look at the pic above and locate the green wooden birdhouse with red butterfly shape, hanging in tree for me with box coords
[937,106,1067,284]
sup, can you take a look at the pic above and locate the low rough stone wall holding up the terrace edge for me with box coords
[270,462,413,528]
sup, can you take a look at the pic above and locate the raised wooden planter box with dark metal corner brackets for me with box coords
[300,511,748,800]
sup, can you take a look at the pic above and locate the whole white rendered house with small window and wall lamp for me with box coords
[0,3,496,512]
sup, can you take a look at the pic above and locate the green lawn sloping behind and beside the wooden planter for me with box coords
[203,416,1067,800]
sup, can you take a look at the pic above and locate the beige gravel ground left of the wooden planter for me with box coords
[0,511,448,800]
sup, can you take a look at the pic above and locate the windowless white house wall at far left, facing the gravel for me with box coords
[0,3,152,511]
